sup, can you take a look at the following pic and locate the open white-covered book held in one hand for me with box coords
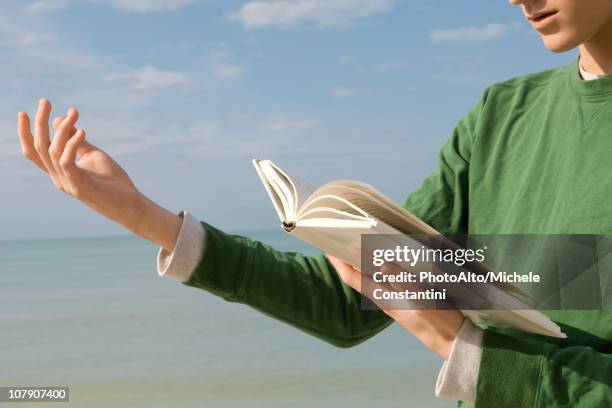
[253,160,566,338]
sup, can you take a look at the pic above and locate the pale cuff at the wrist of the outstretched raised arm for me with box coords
[157,211,206,282]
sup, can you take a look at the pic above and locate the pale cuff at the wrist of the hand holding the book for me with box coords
[436,319,483,405]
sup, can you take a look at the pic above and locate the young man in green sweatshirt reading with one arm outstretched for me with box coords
[14,0,612,407]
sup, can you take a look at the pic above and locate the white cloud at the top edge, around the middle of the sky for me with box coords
[228,0,396,28]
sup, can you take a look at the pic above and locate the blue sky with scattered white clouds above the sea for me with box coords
[0,0,576,239]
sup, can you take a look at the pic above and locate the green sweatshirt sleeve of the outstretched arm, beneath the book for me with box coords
[179,223,392,347]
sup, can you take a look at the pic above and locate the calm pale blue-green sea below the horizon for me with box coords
[0,231,455,408]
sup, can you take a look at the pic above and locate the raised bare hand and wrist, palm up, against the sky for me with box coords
[18,99,181,251]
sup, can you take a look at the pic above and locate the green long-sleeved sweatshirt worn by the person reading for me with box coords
[186,62,612,407]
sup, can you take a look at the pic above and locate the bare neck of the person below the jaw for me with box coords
[580,20,612,75]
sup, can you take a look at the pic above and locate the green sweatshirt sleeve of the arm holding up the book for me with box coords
[475,330,612,408]
